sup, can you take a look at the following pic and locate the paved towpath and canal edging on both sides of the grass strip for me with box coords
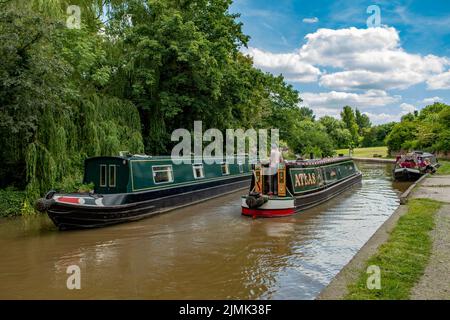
[317,175,450,300]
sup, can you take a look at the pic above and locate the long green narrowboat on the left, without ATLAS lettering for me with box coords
[36,155,252,230]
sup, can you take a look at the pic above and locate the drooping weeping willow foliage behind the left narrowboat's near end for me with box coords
[26,94,144,210]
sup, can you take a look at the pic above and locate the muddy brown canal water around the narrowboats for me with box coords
[0,163,408,299]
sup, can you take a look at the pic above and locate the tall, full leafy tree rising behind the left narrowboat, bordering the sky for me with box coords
[107,0,253,154]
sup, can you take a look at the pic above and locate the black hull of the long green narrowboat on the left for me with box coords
[47,175,251,230]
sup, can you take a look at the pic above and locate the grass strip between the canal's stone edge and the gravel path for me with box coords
[345,199,441,300]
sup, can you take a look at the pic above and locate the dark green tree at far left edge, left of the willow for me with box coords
[0,4,71,187]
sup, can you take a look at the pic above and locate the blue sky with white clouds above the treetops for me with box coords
[230,0,450,123]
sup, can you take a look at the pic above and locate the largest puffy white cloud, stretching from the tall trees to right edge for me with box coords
[248,27,450,90]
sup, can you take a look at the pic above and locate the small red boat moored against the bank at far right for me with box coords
[393,151,439,181]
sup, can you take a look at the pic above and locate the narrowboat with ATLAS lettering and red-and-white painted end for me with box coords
[241,157,362,217]
